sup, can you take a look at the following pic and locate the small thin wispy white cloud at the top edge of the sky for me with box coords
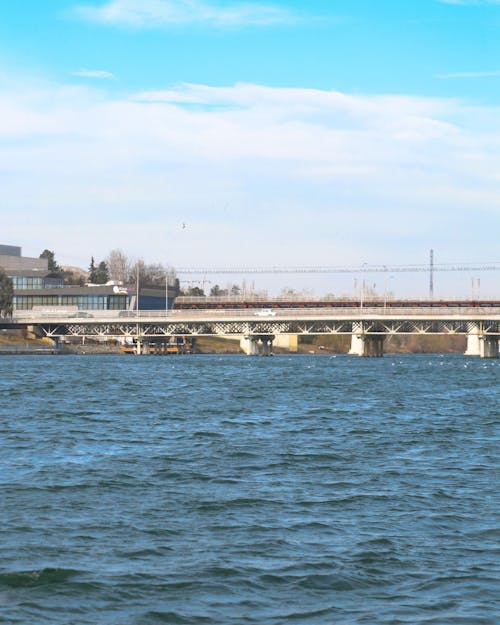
[75,0,294,28]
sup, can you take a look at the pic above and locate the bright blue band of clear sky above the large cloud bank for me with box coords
[0,0,500,102]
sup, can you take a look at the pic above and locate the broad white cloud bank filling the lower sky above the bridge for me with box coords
[0,78,500,292]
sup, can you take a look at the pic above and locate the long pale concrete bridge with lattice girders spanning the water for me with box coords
[0,302,500,358]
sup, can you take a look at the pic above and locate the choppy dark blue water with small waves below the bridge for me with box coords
[0,356,500,625]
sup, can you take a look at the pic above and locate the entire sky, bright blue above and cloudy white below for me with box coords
[0,0,500,294]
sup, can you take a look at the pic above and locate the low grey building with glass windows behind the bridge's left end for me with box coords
[0,245,173,310]
